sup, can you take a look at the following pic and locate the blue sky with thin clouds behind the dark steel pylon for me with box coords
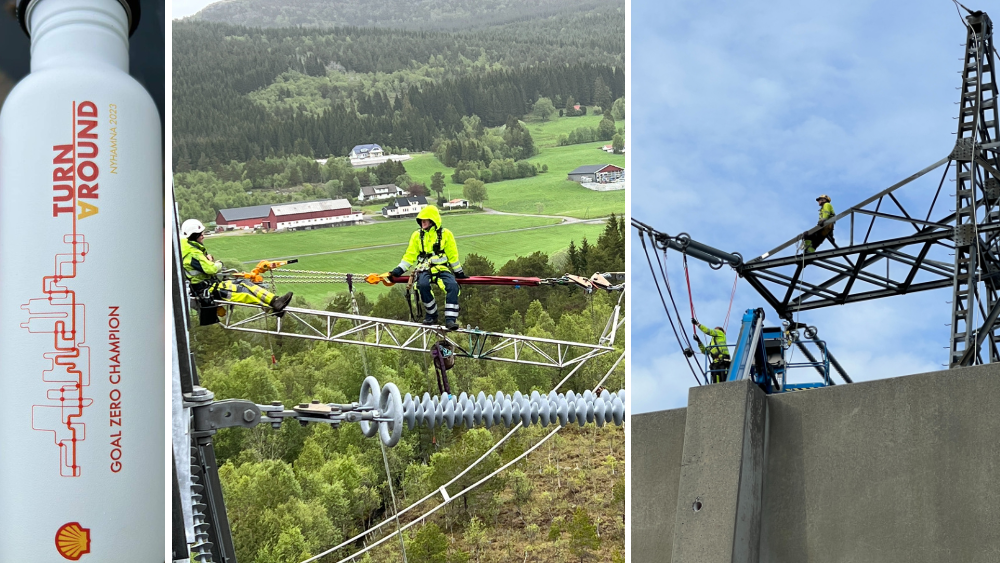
[628,0,976,413]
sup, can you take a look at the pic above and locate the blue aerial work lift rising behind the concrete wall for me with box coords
[706,309,851,394]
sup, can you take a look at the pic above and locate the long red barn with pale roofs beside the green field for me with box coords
[215,199,364,230]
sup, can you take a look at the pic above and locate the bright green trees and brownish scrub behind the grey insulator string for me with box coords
[192,216,625,563]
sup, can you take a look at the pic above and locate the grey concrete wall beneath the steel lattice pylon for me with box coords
[630,366,1000,563]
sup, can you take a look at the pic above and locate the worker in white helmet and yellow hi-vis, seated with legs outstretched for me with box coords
[181,219,292,315]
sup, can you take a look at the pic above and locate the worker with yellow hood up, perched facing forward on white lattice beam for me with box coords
[387,205,469,330]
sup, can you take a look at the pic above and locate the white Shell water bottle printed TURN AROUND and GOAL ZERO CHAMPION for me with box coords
[0,0,166,563]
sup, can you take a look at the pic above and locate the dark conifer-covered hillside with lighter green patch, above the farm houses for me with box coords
[173,12,625,167]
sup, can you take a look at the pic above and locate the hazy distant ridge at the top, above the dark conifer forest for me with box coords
[194,0,625,31]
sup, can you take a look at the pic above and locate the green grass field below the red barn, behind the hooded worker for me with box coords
[206,215,604,306]
